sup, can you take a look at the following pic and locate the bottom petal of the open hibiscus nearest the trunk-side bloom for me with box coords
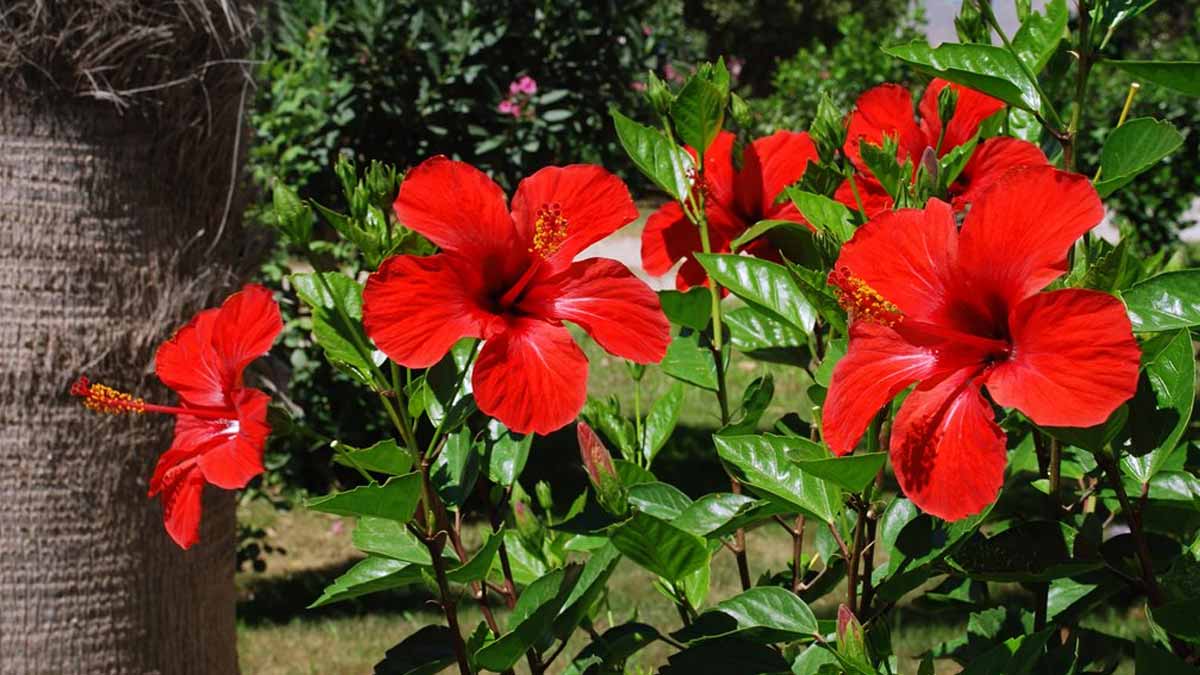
[472,318,588,435]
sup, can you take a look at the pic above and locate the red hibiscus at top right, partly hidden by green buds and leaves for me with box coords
[834,79,1049,217]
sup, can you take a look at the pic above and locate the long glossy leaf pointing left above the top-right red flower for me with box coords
[883,40,1042,112]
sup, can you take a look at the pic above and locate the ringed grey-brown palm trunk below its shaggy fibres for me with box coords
[0,92,253,675]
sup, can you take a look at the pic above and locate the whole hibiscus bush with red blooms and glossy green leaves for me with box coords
[73,0,1200,675]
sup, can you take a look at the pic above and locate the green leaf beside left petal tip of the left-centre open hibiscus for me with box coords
[288,271,373,384]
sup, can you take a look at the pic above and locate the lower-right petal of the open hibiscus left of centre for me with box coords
[520,258,671,364]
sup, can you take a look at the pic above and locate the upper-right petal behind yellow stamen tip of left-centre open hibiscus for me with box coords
[512,165,638,269]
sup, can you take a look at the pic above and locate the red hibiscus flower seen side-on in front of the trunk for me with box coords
[71,285,283,549]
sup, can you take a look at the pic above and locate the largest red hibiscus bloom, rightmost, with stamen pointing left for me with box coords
[823,167,1139,520]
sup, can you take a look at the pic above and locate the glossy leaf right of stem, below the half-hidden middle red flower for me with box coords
[696,253,816,333]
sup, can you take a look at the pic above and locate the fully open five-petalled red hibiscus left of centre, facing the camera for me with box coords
[362,157,670,434]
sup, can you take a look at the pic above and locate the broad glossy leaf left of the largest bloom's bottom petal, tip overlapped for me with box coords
[713,434,841,522]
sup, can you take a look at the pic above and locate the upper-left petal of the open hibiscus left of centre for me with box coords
[392,155,515,257]
